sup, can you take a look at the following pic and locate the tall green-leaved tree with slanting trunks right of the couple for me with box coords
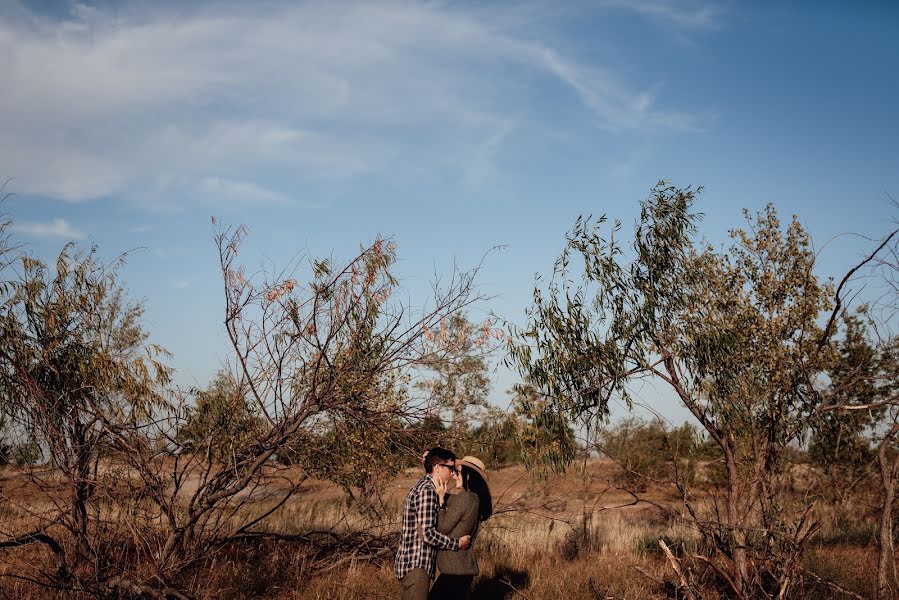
[509,182,833,597]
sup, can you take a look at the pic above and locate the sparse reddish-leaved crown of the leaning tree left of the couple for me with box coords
[215,227,486,524]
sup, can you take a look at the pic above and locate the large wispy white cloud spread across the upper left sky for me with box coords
[0,1,702,203]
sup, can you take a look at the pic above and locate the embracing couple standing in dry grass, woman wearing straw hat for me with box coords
[394,448,493,600]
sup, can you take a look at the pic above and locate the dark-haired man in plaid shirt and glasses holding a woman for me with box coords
[394,448,471,600]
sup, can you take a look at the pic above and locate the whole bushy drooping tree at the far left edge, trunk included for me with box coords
[0,245,169,590]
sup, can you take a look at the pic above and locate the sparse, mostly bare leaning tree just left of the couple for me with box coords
[127,221,479,585]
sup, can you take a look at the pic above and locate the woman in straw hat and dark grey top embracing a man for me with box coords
[428,456,493,600]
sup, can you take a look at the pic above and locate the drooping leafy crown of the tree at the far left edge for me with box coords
[0,245,169,465]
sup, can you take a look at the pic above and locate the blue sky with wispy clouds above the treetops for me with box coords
[0,0,899,418]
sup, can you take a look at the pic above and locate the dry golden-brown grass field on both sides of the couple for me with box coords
[0,460,876,600]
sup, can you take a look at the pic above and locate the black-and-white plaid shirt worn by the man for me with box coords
[393,475,459,579]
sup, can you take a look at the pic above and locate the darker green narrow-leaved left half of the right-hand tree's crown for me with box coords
[509,184,698,432]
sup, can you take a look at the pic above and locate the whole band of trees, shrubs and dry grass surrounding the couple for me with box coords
[0,184,899,600]
